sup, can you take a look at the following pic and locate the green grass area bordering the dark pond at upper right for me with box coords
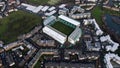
[92,6,120,26]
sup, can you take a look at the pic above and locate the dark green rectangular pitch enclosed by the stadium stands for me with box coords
[51,21,74,35]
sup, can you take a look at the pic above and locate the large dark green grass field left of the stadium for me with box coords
[0,11,41,44]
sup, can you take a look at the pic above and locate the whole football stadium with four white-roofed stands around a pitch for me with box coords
[43,15,82,44]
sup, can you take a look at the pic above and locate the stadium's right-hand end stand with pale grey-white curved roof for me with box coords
[68,27,82,44]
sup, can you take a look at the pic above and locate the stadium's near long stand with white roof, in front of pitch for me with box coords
[43,25,67,44]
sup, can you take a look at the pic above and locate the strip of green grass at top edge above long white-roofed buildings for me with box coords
[27,0,60,5]
